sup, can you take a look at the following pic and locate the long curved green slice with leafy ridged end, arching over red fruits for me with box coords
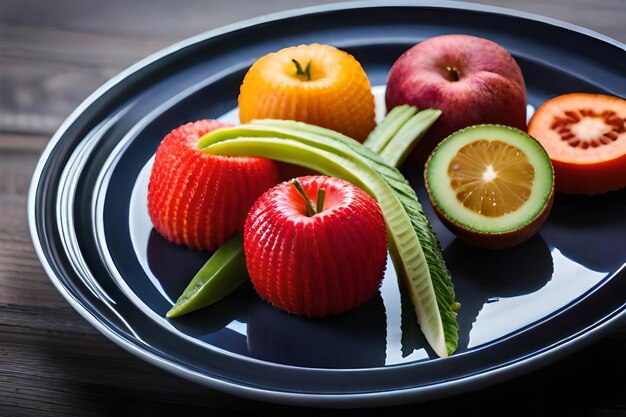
[198,121,458,357]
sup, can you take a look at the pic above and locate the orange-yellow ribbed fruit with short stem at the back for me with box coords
[239,43,376,142]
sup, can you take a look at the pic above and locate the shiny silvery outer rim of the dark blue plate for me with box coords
[27,1,626,407]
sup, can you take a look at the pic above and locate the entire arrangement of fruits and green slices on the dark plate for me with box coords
[147,35,626,357]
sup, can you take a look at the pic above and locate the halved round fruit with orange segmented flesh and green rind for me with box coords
[424,125,554,248]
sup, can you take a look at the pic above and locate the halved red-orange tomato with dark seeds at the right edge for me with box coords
[528,93,626,194]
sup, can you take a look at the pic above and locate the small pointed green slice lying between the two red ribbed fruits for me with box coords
[166,233,250,318]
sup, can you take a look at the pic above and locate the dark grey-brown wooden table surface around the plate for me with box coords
[0,0,626,416]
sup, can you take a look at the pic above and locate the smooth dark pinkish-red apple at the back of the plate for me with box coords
[385,35,526,165]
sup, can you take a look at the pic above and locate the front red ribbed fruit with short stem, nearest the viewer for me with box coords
[244,175,387,317]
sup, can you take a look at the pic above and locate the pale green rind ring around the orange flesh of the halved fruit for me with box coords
[425,124,554,235]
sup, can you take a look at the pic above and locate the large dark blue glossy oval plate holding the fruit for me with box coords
[29,2,626,406]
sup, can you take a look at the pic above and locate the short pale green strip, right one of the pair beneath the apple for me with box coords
[377,108,441,167]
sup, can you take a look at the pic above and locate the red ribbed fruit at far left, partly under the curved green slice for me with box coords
[148,120,278,250]
